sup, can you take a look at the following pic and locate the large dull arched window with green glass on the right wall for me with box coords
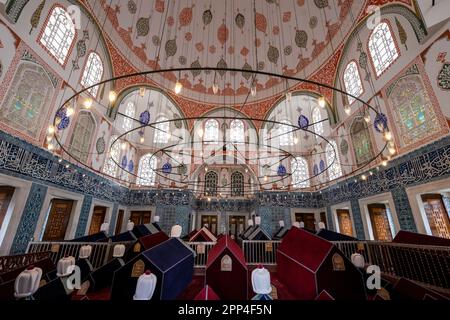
[389,74,440,145]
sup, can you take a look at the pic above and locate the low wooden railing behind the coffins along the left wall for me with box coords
[27,241,134,269]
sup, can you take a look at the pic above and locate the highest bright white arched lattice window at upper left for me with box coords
[39,6,75,65]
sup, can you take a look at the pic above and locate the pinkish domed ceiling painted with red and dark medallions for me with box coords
[87,0,369,104]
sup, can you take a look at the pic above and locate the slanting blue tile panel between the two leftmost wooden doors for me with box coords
[10,183,48,254]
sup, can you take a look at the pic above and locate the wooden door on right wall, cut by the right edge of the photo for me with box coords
[422,194,450,239]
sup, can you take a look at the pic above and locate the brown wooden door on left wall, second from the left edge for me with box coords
[42,199,73,241]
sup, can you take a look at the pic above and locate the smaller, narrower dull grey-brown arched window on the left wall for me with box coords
[69,112,95,163]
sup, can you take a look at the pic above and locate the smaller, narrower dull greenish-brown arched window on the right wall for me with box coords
[350,118,373,165]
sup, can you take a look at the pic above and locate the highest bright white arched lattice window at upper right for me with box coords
[369,22,399,77]
